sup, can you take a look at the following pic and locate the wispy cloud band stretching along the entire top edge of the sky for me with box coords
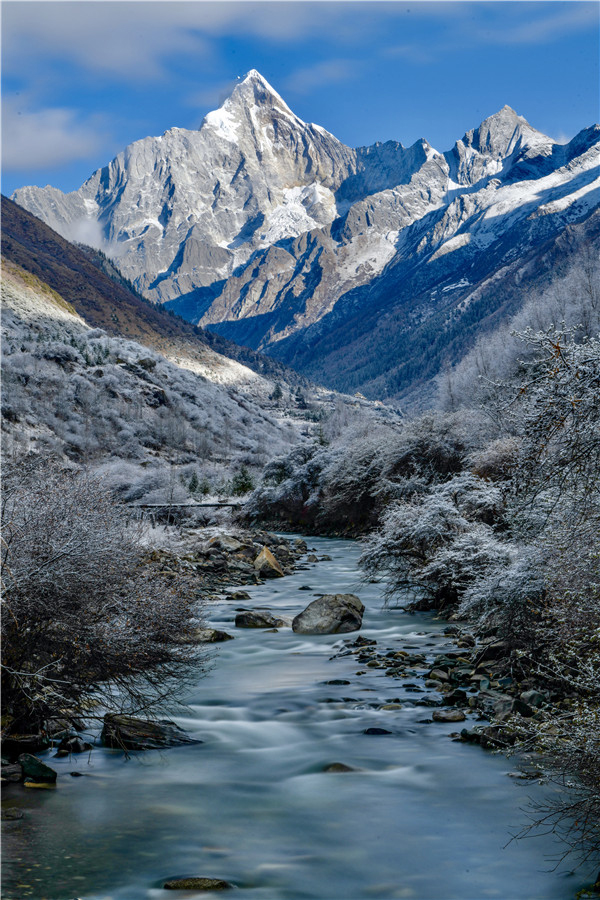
[3,0,598,89]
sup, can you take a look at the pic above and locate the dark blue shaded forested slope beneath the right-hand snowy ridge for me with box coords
[270,208,600,407]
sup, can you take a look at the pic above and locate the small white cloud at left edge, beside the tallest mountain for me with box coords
[2,100,105,172]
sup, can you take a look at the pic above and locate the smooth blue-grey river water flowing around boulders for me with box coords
[3,538,595,900]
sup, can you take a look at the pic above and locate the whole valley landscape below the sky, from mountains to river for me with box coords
[1,54,600,900]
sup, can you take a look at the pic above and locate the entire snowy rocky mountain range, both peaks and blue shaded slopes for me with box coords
[14,71,600,402]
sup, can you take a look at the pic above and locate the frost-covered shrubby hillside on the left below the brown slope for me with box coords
[2,260,310,502]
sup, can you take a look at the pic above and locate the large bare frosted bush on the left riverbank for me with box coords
[1,459,206,733]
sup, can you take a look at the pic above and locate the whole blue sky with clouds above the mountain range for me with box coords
[2,0,600,194]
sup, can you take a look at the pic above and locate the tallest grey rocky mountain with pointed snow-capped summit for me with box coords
[13,70,355,301]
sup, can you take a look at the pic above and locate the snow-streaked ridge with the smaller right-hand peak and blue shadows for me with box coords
[200,109,600,356]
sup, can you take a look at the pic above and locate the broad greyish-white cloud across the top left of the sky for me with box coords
[2,0,324,81]
